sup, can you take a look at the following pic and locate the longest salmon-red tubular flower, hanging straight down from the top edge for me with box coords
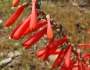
[30,0,38,31]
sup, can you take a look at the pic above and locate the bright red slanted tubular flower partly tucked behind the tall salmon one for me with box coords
[13,16,31,40]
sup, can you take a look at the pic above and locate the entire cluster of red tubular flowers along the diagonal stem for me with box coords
[5,0,90,70]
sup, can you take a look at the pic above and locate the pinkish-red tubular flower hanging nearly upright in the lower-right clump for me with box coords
[64,45,73,67]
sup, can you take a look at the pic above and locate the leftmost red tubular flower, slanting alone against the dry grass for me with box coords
[5,5,24,27]
